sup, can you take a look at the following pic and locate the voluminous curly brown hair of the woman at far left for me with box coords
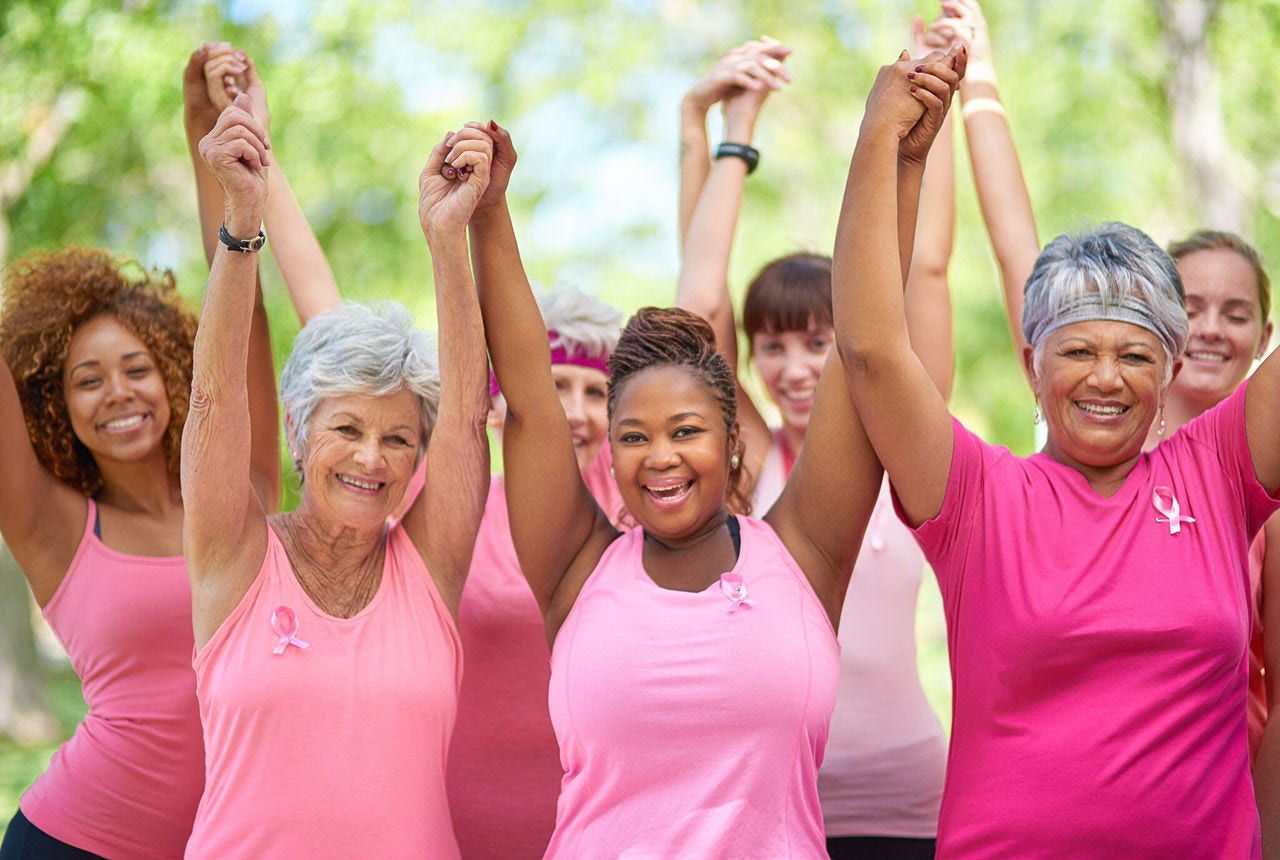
[0,248,196,497]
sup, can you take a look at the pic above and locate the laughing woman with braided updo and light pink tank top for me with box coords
[471,75,945,857]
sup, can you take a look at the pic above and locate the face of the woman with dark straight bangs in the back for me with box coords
[751,325,835,430]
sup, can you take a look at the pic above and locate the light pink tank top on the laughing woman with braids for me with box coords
[547,517,838,860]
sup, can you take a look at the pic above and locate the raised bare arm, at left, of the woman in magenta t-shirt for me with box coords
[832,45,965,525]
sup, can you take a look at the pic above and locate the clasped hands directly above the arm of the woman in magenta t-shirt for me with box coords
[863,42,968,164]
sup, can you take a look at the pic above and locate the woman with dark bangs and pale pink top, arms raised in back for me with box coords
[676,30,955,857]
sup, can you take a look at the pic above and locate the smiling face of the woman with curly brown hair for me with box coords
[63,316,170,467]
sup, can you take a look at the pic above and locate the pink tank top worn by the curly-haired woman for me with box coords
[20,500,205,857]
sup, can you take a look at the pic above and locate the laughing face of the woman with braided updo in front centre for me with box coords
[609,365,737,540]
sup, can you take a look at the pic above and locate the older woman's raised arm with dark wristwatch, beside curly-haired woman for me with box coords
[182,95,270,648]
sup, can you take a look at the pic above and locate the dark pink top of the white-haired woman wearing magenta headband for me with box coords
[448,445,622,860]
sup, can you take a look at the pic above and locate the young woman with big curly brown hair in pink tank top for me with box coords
[0,241,279,860]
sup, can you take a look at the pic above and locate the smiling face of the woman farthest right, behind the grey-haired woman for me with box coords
[1174,248,1271,408]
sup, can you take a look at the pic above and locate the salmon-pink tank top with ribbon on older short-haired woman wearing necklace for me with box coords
[187,525,462,860]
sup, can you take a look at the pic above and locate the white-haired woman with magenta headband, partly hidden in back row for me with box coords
[448,287,622,860]
